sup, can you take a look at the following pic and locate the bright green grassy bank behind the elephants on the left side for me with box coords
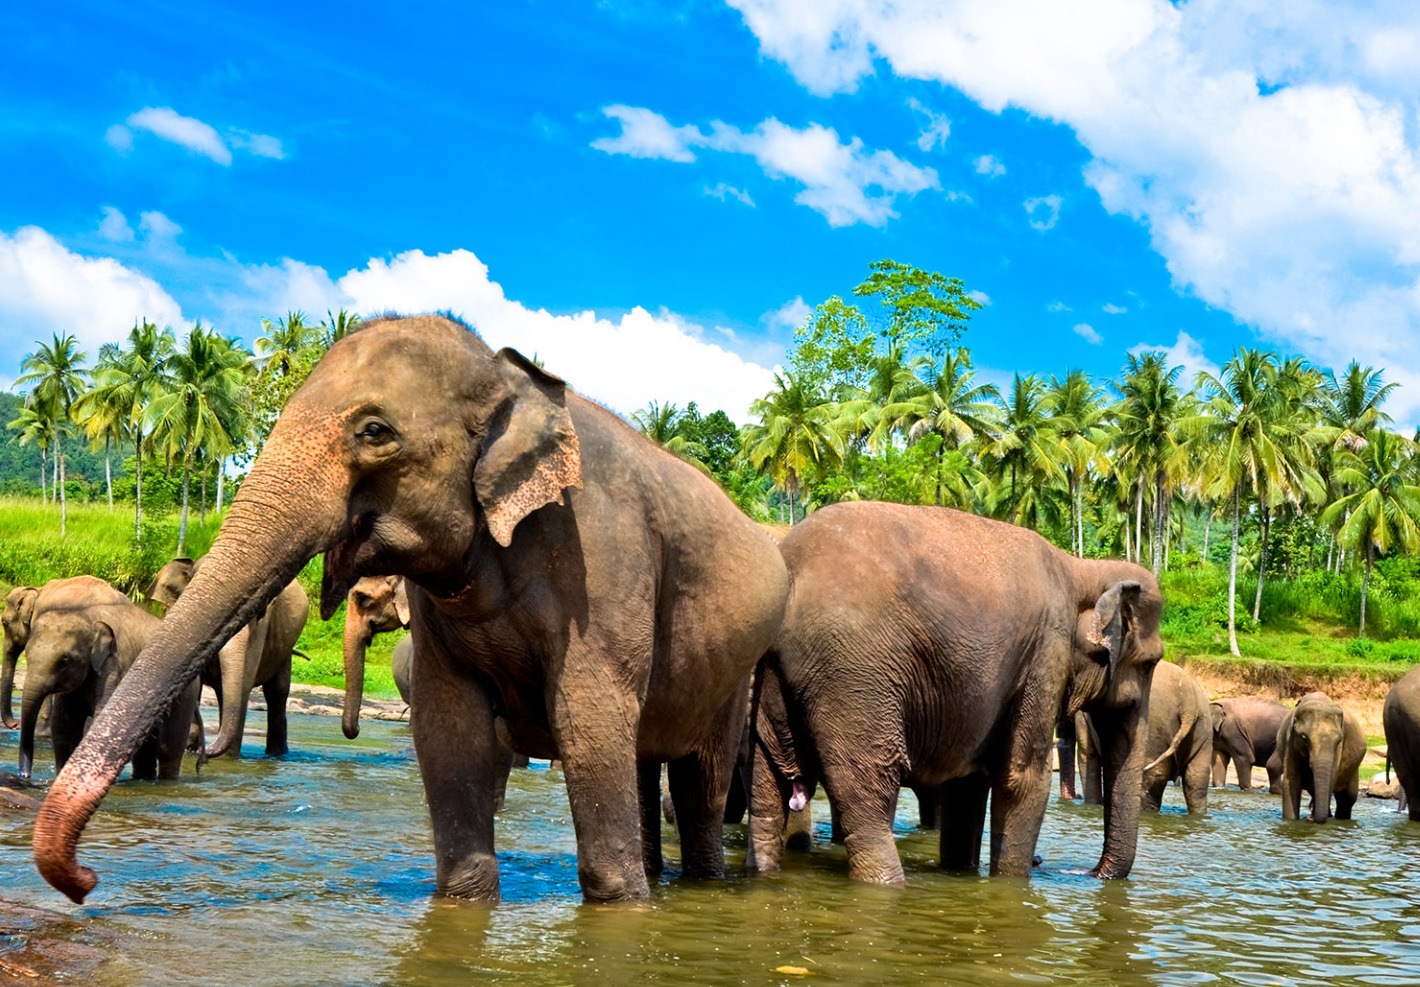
[0,497,400,699]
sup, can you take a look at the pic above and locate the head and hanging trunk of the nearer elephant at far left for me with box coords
[20,611,119,778]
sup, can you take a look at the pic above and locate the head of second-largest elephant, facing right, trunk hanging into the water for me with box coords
[1065,562,1163,878]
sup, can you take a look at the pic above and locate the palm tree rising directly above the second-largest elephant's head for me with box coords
[1113,352,1186,578]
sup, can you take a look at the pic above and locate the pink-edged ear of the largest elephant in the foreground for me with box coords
[473,349,582,548]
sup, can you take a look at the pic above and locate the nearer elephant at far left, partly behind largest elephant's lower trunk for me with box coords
[20,575,202,778]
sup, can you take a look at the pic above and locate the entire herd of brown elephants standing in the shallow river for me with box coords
[8,315,1420,902]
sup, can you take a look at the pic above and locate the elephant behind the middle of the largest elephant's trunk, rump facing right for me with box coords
[146,558,311,757]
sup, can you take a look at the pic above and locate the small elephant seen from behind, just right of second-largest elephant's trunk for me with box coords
[1142,662,1213,815]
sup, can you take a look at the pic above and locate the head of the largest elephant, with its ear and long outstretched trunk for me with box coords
[34,315,581,900]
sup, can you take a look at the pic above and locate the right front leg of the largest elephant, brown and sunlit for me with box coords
[548,664,650,902]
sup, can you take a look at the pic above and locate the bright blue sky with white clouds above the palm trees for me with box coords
[0,0,1420,423]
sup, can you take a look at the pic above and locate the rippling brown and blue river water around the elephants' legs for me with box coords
[0,716,1420,987]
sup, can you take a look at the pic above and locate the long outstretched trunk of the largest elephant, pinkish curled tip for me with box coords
[33,406,349,902]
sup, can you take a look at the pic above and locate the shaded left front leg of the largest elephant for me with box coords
[409,639,500,902]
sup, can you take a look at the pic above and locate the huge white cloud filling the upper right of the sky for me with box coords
[728,0,1420,420]
